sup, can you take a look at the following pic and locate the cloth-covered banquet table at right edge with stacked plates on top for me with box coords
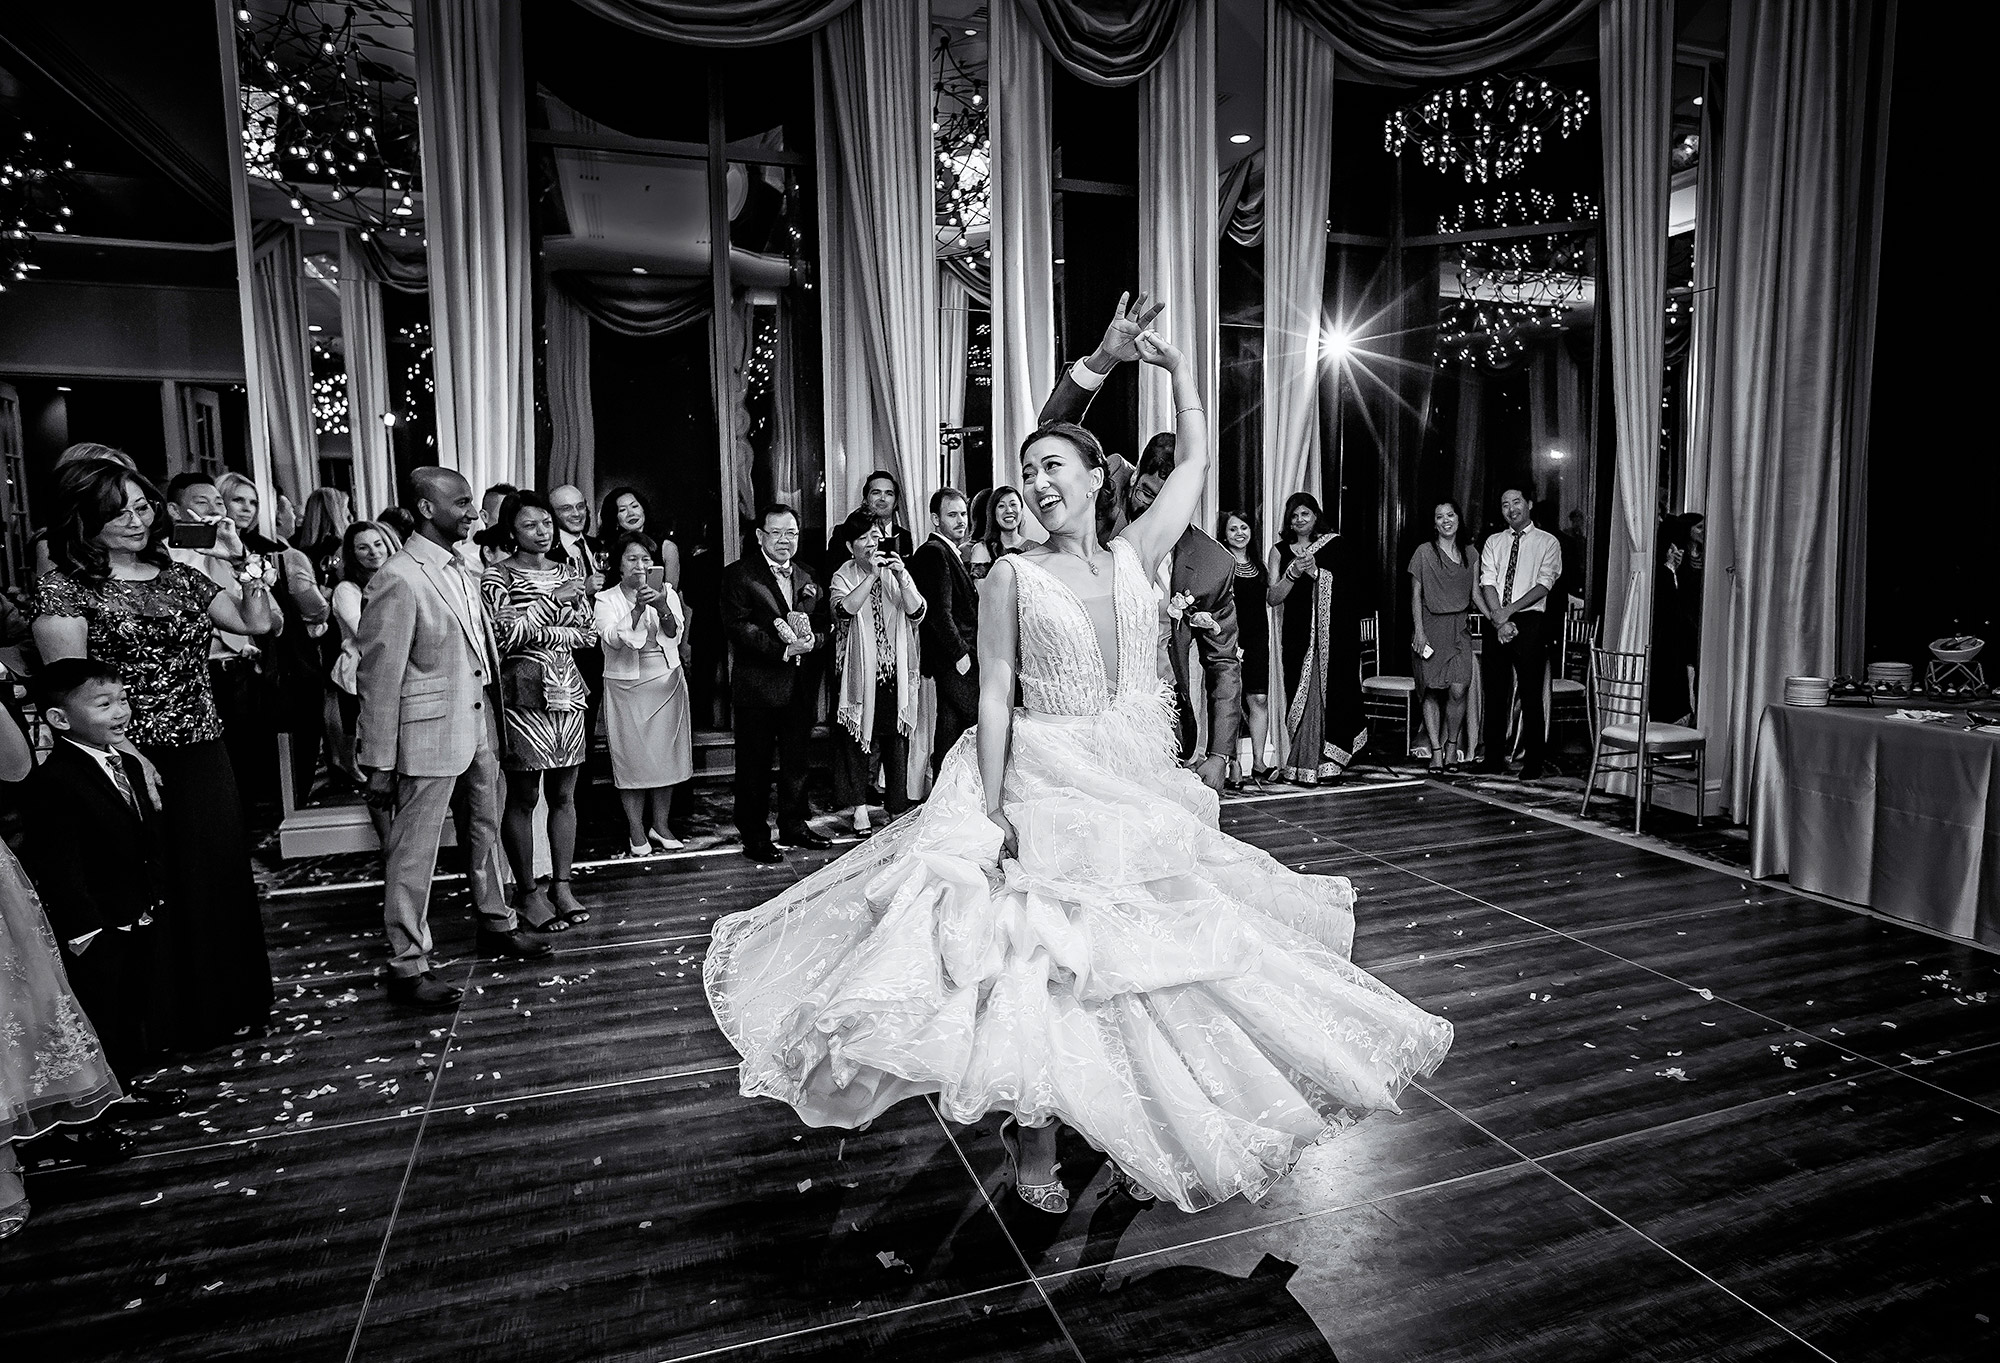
[1750,701,2000,945]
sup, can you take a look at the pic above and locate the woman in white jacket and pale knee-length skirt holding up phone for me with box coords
[594,530,694,857]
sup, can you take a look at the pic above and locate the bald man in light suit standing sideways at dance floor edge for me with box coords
[354,468,554,1007]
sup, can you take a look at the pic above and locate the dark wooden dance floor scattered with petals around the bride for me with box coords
[0,785,2000,1363]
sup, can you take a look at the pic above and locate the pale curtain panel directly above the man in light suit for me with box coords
[414,0,534,492]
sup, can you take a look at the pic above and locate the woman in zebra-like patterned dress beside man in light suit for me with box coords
[480,492,598,933]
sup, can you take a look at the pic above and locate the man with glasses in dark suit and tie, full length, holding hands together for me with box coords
[722,506,834,865]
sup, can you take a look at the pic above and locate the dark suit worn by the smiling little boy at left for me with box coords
[22,739,171,1081]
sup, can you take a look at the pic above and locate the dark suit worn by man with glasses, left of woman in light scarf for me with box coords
[722,550,834,847]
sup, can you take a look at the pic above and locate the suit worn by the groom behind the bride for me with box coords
[1040,366,1244,759]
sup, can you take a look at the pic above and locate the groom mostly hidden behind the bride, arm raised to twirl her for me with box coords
[1040,294,1244,795]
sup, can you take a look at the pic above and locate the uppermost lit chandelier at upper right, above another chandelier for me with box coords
[1382,76,1590,184]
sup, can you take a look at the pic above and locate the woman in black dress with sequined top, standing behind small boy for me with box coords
[34,460,278,1051]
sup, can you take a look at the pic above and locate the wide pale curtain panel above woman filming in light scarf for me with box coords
[814,0,938,524]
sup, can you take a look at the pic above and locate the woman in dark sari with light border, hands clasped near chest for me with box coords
[1268,492,1368,785]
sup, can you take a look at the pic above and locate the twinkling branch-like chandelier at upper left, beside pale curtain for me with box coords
[236,0,422,240]
